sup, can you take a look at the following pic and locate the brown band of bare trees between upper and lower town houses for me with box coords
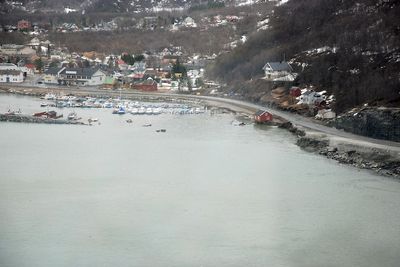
[49,27,233,54]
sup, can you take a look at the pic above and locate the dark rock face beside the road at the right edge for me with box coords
[330,108,400,142]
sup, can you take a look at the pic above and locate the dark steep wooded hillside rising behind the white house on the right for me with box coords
[209,0,400,112]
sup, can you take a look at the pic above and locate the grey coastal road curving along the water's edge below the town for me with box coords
[3,86,400,153]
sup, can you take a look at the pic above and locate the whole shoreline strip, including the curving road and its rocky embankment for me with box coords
[0,86,400,179]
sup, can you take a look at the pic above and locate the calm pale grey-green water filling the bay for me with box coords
[0,95,400,267]
